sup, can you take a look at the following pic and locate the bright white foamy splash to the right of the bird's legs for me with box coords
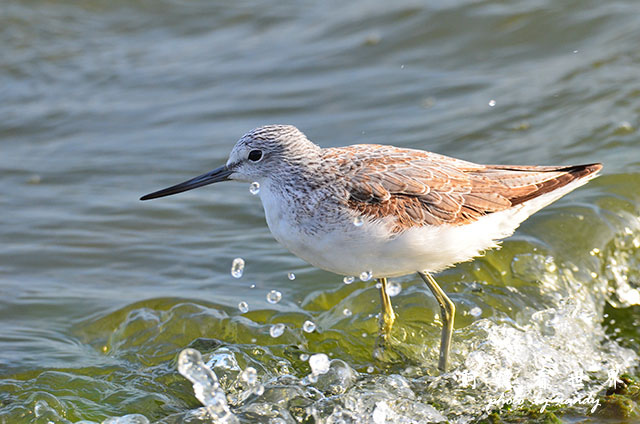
[428,301,637,417]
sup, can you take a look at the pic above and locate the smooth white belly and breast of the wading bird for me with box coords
[262,186,520,277]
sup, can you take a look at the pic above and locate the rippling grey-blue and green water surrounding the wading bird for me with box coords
[0,0,640,423]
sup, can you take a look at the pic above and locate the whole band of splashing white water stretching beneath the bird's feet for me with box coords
[170,286,637,423]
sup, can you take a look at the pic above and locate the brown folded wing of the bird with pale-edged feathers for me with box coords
[328,145,602,231]
